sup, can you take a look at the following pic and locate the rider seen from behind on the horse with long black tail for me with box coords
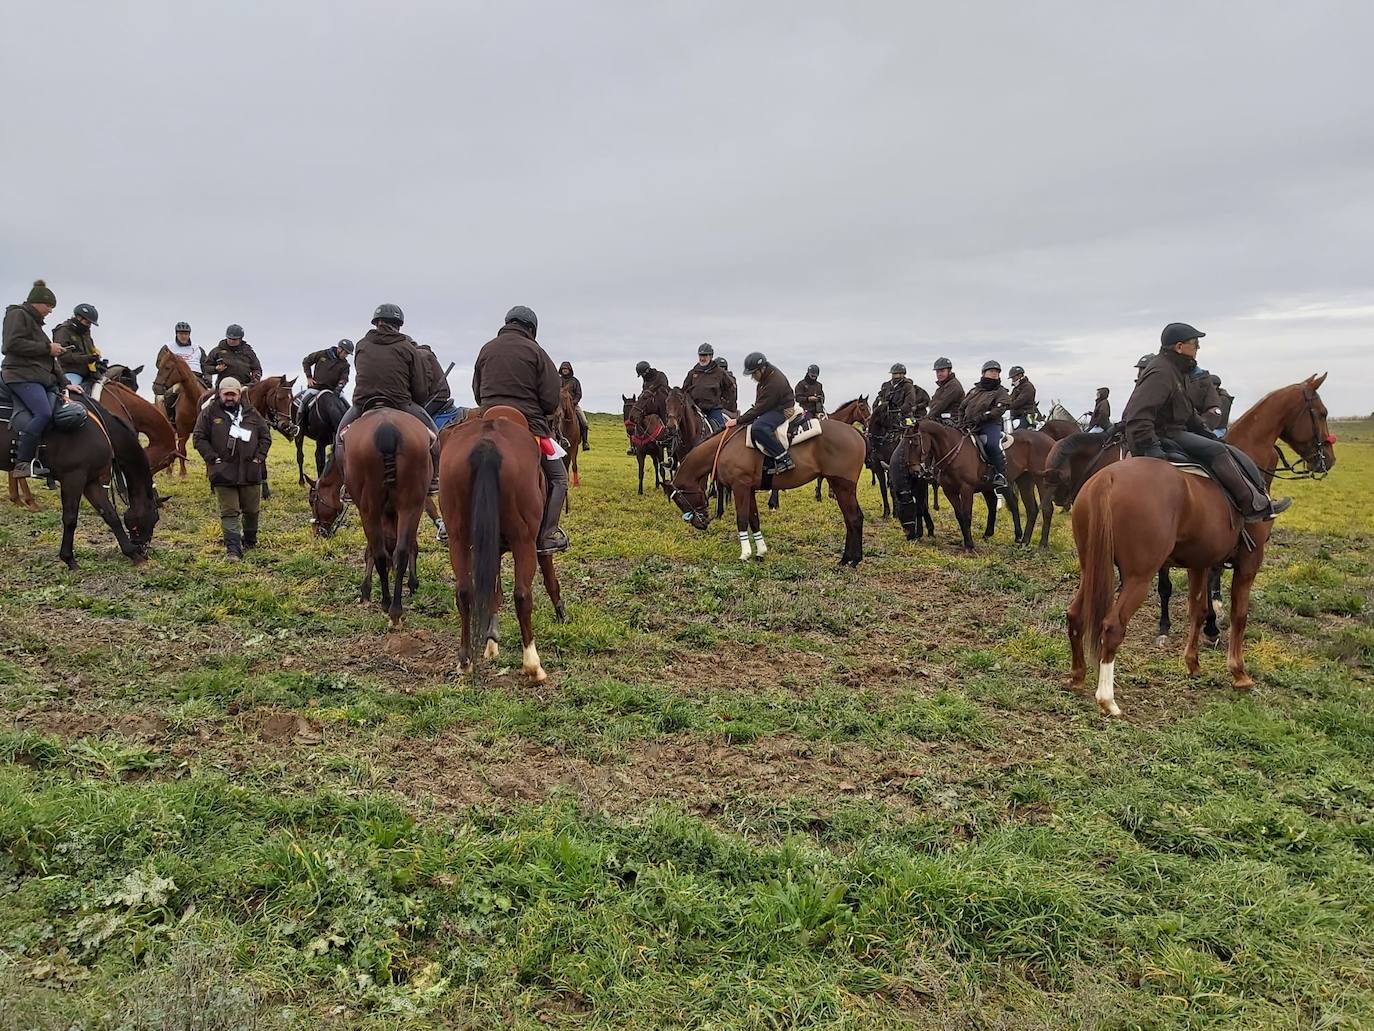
[473,304,567,555]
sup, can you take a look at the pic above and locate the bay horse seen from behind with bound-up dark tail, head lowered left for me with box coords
[311,408,434,630]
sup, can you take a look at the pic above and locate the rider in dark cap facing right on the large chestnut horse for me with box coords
[1121,322,1293,522]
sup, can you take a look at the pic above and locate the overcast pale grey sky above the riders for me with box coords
[0,0,1374,414]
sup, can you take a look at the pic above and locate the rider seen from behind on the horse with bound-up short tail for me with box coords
[334,304,438,494]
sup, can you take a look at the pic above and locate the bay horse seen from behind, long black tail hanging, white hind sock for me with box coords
[442,406,567,683]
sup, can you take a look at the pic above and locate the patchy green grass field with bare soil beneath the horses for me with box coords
[0,417,1374,1031]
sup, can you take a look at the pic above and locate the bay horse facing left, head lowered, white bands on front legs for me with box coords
[664,419,864,568]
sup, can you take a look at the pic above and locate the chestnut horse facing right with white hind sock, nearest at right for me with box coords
[1066,373,1336,716]
